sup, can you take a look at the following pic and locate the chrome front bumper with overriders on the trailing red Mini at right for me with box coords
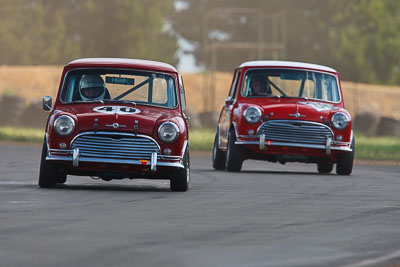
[235,134,353,155]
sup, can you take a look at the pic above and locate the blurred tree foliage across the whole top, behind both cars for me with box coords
[0,0,400,84]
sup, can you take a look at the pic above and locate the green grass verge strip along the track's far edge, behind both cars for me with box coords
[0,127,400,162]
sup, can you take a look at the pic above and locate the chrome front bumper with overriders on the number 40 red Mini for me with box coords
[46,148,184,172]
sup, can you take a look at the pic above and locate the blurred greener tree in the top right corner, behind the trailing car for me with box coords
[321,0,400,84]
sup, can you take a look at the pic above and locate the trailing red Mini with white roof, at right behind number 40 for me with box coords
[213,61,355,175]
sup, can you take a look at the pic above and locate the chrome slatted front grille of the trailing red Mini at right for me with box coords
[257,120,333,145]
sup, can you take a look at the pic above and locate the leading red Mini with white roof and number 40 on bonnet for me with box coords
[39,58,190,191]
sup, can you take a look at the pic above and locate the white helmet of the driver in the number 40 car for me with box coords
[79,74,106,101]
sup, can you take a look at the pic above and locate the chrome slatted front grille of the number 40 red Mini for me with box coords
[72,133,160,160]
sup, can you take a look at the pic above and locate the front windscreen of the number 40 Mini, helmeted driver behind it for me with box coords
[61,69,177,107]
